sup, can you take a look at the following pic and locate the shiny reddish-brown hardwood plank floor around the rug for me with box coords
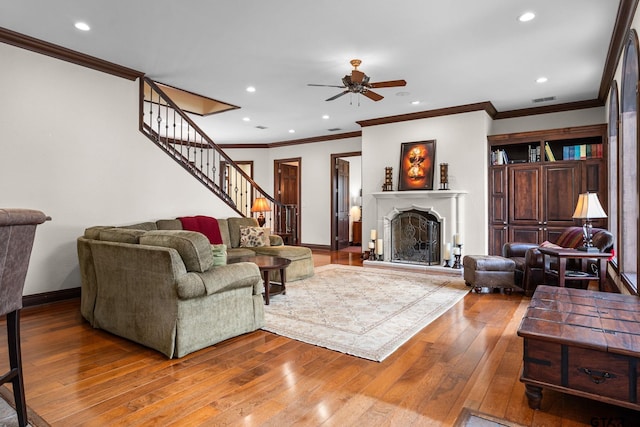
[0,252,640,427]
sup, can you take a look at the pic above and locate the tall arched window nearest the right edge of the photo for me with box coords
[618,30,639,291]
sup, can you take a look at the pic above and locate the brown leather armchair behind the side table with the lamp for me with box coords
[502,227,613,296]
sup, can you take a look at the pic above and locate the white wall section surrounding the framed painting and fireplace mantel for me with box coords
[362,111,489,254]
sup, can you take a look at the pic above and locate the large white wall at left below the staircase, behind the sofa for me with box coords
[0,43,235,295]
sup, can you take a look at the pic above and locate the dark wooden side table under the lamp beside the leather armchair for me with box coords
[538,247,611,291]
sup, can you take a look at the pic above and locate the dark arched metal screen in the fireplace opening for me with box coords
[391,209,440,265]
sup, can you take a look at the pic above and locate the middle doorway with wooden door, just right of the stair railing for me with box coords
[273,157,302,245]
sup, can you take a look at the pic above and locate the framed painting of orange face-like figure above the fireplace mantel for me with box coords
[398,139,436,191]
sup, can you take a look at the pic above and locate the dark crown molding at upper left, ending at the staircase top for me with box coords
[0,27,144,80]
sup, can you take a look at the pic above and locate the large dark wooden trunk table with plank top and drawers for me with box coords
[518,285,640,410]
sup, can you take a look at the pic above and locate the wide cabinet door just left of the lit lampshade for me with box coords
[543,162,581,226]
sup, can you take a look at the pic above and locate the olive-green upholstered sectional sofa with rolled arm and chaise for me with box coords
[77,218,313,358]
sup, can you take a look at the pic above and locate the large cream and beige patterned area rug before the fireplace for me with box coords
[263,264,469,361]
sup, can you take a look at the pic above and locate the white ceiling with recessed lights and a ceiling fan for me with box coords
[0,0,619,144]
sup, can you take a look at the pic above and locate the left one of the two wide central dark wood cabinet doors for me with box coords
[509,165,542,224]
